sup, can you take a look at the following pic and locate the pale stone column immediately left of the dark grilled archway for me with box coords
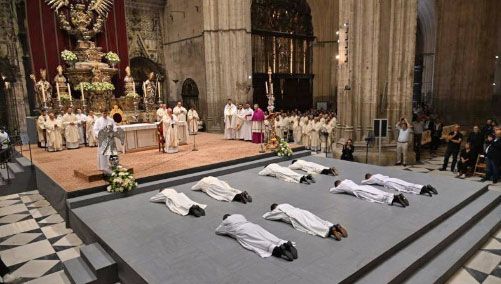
[203,0,252,132]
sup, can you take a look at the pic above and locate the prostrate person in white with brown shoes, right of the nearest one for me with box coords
[263,203,348,241]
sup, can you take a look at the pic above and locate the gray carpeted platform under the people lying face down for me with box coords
[70,157,500,284]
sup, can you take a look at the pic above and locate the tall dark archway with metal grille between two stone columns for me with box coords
[251,0,315,110]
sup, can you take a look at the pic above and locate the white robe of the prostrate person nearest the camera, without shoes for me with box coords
[216,214,287,257]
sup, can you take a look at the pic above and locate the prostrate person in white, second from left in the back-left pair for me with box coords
[191,176,252,204]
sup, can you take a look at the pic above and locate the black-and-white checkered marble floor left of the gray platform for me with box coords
[0,191,82,284]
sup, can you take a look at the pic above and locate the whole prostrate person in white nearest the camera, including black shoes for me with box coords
[216,214,297,261]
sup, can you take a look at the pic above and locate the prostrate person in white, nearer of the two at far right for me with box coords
[330,179,409,207]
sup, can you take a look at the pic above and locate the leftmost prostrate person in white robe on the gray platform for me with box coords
[150,188,207,217]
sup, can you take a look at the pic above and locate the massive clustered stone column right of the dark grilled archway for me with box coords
[337,0,417,163]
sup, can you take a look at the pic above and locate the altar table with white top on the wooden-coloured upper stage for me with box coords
[117,123,158,154]
